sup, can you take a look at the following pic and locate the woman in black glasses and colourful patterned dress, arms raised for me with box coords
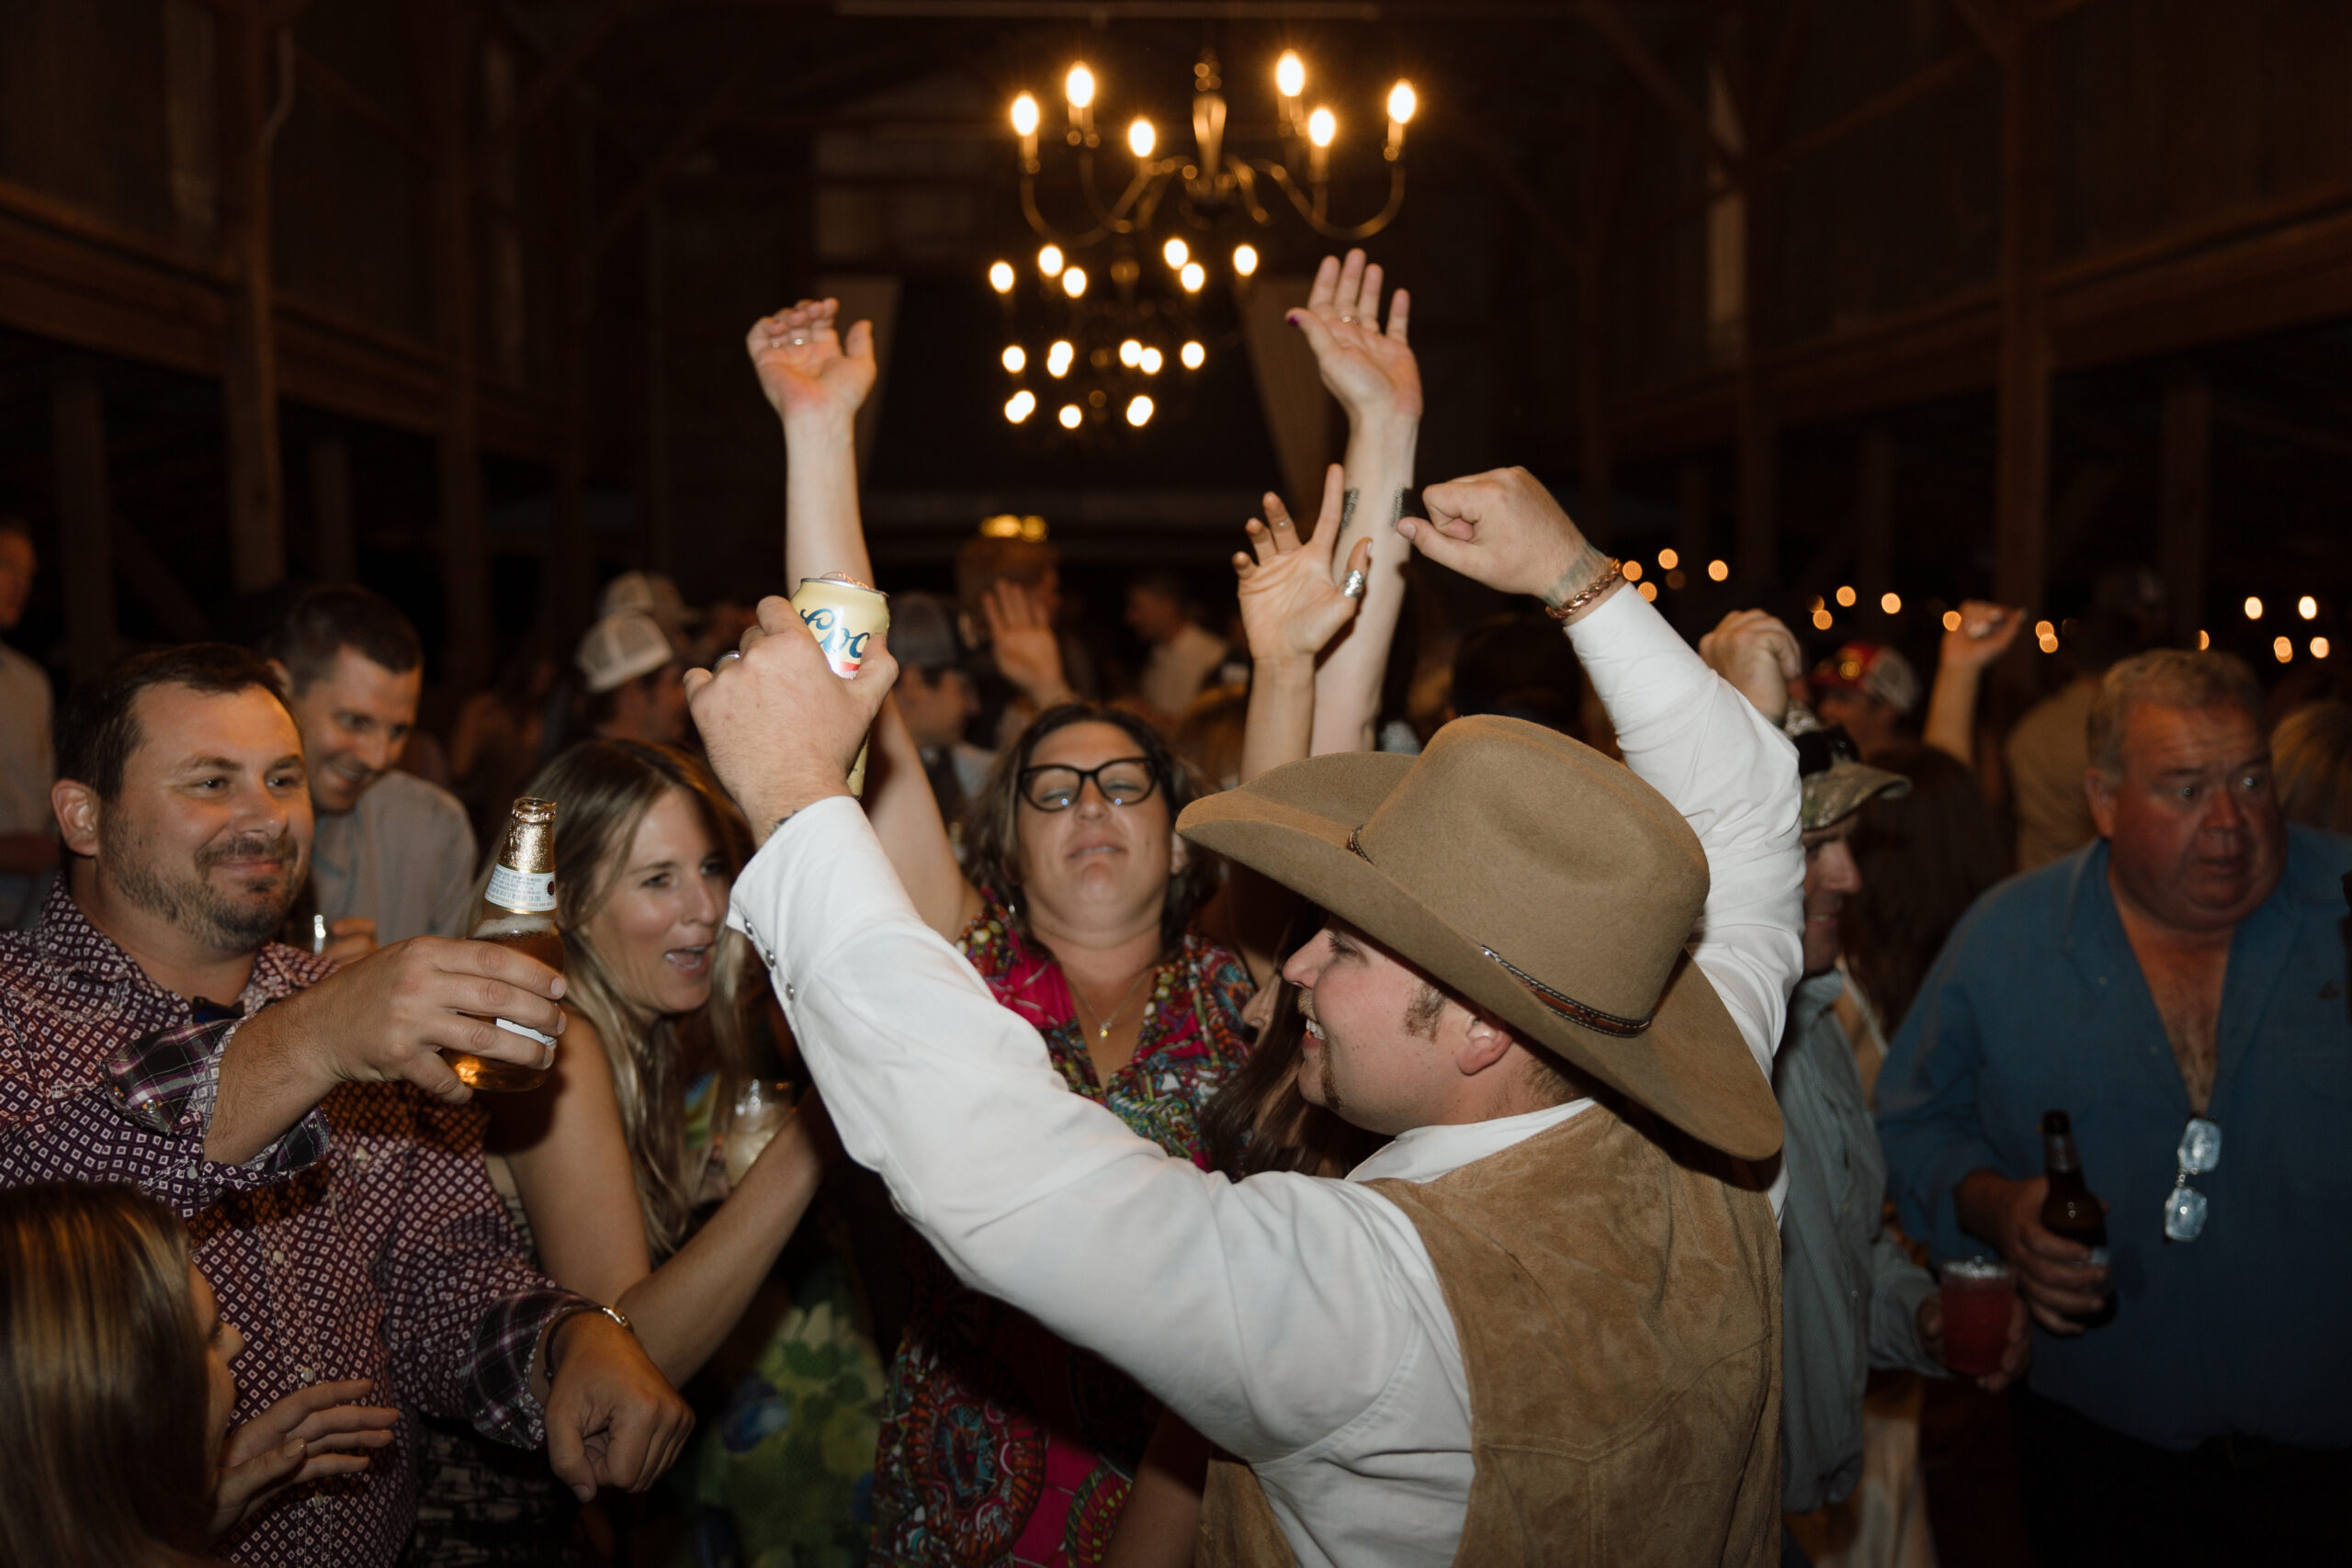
[748,245,1419,1568]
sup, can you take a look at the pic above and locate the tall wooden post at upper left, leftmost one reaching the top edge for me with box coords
[217,5,287,592]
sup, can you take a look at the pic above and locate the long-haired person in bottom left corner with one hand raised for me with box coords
[0,1182,400,1568]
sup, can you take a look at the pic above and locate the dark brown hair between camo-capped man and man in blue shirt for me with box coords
[1839,740,2008,1037]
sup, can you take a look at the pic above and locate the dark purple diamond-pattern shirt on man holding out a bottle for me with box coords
[0,886,591,1568]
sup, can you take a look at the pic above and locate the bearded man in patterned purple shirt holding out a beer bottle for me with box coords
[0,644,692,1568]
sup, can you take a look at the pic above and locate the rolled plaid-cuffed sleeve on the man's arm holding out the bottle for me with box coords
[0,1021,327,1218]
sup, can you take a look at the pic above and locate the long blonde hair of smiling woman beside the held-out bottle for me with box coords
[507,740,767,1260]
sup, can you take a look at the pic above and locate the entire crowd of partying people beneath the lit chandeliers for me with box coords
[0,252,2352,1568]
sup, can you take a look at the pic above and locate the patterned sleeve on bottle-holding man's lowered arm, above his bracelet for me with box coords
[379,1096,595,1448]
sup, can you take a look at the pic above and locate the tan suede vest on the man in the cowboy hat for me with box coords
[1197,1107,1781,1568]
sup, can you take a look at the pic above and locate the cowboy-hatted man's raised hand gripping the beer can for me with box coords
[687,594,899,840]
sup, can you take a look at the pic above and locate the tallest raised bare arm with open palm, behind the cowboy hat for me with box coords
[1289,252,1420,755]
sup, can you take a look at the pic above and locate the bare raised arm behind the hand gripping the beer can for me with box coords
[746,299,981,938]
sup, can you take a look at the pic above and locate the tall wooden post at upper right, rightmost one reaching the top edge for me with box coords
[1992,0,2051,629]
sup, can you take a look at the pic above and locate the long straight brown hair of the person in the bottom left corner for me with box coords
[0,1182,214,1568]
